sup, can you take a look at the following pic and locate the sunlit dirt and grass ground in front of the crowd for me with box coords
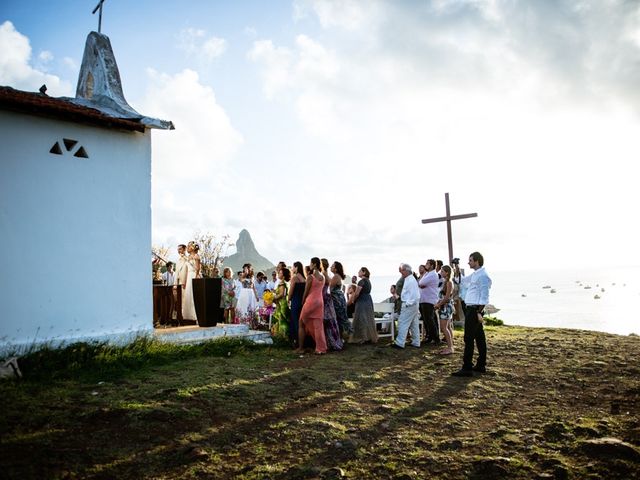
[0,327,640,479]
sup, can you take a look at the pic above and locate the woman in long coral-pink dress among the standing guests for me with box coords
[296,257,327,355]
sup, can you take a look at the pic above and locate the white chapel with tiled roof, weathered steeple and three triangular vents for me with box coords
[0,32,173,355]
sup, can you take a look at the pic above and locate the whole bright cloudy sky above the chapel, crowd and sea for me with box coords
[0,0,640,275]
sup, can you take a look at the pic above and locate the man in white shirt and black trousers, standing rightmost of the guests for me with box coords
[451,252,491,377]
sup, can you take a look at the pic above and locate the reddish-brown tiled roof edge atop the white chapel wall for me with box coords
[0,86,146,132]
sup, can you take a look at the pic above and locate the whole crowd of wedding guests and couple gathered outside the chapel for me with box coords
[158,242,492,377]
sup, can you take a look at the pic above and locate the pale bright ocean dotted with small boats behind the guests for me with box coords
[371,266,640,335]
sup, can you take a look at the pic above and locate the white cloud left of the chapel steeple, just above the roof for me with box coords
[0,21,72,96]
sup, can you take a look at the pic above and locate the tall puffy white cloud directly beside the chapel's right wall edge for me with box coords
[140,69,243,245]
